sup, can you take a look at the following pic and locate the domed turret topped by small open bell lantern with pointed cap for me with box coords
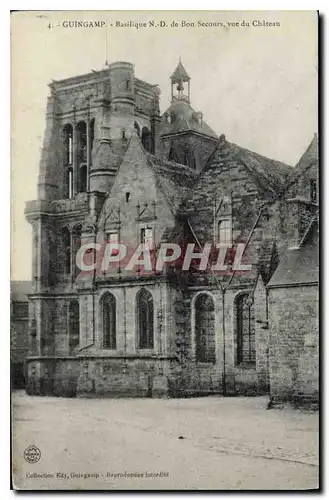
[160,60,218,171]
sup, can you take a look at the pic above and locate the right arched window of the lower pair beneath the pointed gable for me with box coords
[137,290,154,349]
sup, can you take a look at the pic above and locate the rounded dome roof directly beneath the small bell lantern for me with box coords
[160,99,217,139]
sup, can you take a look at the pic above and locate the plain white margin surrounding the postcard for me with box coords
[0,0,329,500]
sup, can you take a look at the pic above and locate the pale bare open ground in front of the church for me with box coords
[13,392,318,490]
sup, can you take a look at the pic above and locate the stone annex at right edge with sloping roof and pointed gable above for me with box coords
[267,137,319,405]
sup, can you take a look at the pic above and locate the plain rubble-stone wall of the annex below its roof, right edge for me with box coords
[269,286,319,402]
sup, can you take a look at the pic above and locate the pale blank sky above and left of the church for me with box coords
[11,11,317,279]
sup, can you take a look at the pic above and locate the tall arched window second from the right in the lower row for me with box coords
[195,293,216,363]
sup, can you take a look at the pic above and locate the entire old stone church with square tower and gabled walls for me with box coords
[26,61,319,402]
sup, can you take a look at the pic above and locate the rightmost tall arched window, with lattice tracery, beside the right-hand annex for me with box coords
[236,294,256,364]
